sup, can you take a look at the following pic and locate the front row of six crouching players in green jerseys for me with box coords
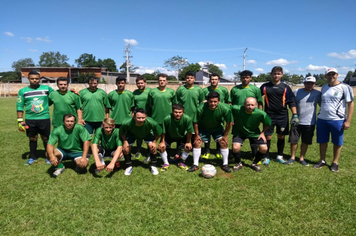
[47,92,271,177]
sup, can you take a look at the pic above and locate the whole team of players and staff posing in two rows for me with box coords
[17,66,354,177]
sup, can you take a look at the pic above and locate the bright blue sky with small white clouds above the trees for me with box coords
[0,0,356,79]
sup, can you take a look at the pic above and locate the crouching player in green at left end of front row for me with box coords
[47,114,91,177]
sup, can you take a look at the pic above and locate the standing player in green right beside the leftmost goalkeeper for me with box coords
[49,77,83,128]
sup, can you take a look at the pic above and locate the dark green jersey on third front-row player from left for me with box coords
[120,117,162,139]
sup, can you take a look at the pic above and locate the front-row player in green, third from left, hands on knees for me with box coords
[120,108,162,175]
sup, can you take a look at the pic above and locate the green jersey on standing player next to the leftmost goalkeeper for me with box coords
[49,90,82,127]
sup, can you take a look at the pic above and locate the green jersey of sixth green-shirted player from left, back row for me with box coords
[176,85,205,117]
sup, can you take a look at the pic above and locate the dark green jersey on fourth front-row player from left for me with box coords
[162,114,194,140]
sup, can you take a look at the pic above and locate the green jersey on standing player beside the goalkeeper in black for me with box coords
[229,84,262,106]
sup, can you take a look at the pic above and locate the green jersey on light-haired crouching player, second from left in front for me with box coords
[93,127,122,150]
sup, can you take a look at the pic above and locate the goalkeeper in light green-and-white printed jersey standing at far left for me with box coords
[16,71,53,165]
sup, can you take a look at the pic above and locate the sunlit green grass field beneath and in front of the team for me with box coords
[0,98,356,235]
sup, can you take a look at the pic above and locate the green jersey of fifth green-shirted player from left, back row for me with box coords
[147,88,176,124]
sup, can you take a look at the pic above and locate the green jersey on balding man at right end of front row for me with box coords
[232,105,271,138]
